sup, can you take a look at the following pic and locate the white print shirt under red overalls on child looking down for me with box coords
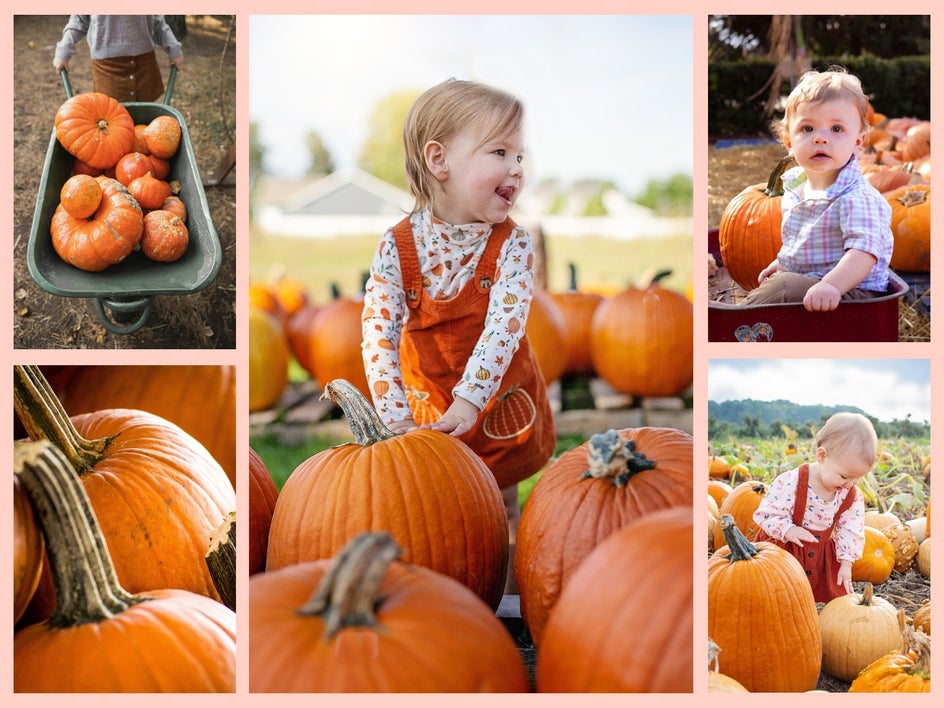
[754,469,865,562]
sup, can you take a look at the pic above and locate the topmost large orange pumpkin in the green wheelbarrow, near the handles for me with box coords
[53,92,134,170]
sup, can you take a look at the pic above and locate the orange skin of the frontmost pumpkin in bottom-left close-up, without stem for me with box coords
[13,590,236,693]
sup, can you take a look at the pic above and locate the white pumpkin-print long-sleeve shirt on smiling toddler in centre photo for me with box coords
[361,211,534,425]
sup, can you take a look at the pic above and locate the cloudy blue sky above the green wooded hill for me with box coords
[708,359,931,422]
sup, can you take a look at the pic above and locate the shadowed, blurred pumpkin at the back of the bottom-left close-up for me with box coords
[41,365,236,486]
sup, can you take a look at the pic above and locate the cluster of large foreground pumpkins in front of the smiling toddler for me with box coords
[249,381,693,692]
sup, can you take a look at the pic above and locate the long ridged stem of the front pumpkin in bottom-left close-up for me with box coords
[13,440,147,627]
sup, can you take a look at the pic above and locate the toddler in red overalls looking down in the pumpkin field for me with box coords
[754,413,878,602]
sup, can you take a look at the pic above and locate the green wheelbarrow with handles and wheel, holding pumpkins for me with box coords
[27,66,222,334]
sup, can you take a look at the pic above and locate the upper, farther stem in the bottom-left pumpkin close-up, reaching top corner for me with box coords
[13,365,112,474]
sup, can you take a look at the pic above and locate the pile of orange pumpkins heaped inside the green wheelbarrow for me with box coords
[50,93,189,272]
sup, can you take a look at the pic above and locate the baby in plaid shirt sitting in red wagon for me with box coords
[743,69,893,311]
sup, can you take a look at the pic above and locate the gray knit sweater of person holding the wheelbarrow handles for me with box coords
[56,15,182,61]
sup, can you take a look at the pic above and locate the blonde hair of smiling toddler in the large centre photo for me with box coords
[403,79,524,214]
